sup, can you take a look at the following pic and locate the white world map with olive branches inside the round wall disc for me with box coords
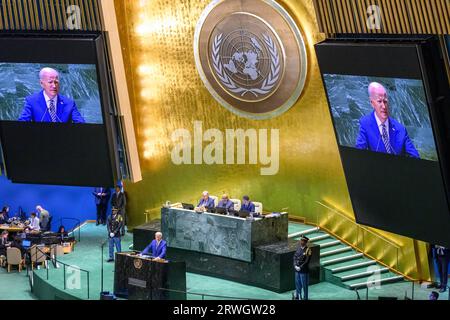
[211,30,281,98]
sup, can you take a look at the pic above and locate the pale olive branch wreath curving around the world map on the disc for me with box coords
[212,33,281,97]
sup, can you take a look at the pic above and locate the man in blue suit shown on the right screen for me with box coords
[356,82,420,159]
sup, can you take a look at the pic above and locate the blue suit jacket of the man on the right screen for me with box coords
[356,112,420,158]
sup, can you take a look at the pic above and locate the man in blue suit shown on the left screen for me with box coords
[18,68,86,123]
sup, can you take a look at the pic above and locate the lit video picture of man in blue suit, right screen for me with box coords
[323,74,438,161]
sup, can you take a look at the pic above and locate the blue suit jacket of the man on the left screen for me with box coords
[18,91,86,123]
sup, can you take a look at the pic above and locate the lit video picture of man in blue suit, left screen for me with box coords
[0,62,103,124]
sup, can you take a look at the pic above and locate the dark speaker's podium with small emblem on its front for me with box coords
[114,252,186,300]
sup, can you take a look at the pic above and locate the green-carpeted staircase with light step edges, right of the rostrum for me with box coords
[289,223,404,290]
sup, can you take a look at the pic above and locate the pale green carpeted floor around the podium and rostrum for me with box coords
[9,223,446,300]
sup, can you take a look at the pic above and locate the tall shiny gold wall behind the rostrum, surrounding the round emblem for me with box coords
[114,0,430,279]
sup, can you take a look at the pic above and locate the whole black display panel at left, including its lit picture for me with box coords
[0,33,119,186]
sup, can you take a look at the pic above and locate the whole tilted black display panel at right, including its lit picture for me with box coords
[316,38,450,245]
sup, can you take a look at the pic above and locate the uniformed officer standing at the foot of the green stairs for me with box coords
[293,236,312,300]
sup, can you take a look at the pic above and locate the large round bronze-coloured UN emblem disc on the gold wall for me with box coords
[194,0,307,119]
